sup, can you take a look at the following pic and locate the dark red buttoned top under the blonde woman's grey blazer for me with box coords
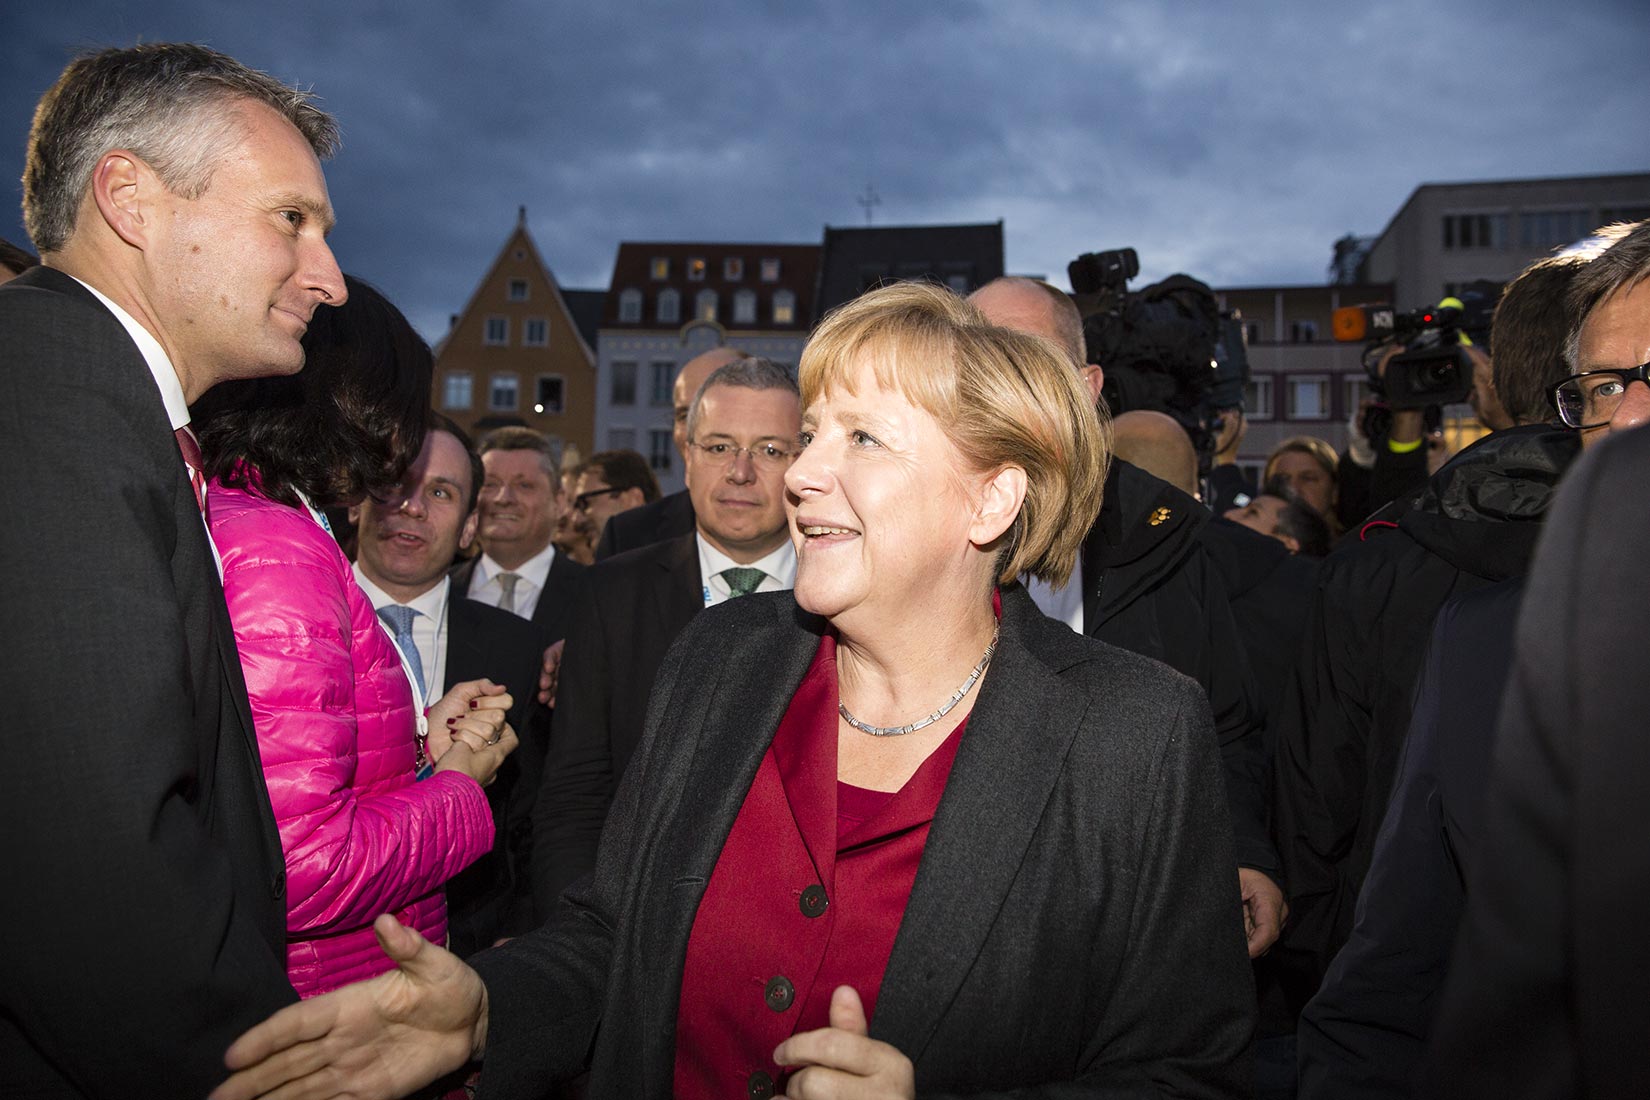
[672,635,967,1100]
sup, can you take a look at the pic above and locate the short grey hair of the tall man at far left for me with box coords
[23,43,338,252]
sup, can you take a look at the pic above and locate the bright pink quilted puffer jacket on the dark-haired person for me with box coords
[208,482,493,996]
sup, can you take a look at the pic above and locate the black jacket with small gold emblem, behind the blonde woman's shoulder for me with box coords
[1082,460,1282,881]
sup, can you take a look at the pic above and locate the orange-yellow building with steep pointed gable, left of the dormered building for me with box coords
[434,206,596,455]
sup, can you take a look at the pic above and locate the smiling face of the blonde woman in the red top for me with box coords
[785,363,993,633]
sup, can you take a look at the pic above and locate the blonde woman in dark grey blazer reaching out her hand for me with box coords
[218,284,1254,1100]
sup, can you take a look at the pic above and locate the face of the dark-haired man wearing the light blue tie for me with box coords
[356,430,475,602]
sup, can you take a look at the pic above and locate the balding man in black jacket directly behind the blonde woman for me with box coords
[969,277,1285,957]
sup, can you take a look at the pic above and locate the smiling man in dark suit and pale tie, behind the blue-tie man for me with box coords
[452,427,584,638]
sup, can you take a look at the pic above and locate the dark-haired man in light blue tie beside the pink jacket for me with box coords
[350,412,558,958]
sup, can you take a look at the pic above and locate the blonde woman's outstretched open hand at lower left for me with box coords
[210,915,487,1100]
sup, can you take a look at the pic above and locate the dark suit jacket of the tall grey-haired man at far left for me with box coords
[0,267,297,1097]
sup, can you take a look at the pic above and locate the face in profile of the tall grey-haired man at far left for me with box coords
[145,101,345,386]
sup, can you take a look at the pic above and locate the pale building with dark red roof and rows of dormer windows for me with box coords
[594,241,820,493]
